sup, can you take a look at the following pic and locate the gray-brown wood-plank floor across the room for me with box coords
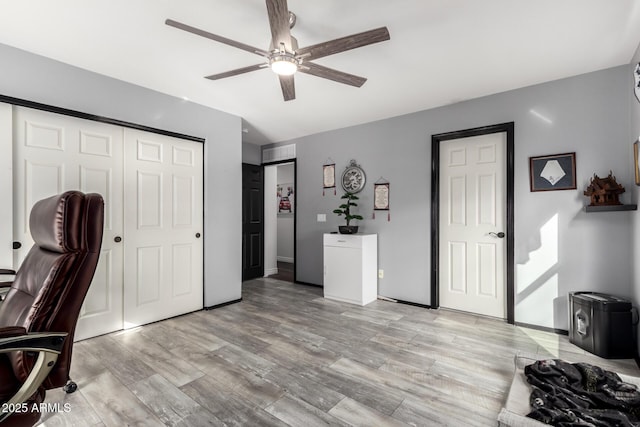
[36,279,640,427]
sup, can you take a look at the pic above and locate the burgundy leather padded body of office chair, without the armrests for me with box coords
[0,191,104,389]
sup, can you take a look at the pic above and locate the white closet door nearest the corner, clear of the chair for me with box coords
[123,129,203,328]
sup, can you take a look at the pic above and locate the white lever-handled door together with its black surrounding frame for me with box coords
[431,122,514,323]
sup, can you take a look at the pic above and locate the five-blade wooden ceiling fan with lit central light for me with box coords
[165,0,390,101]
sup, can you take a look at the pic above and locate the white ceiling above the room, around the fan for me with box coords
[0,0,640,144]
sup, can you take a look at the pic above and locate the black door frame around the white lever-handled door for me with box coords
[431,122,515,324]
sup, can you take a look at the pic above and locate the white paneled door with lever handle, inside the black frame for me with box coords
[439,132,506,318]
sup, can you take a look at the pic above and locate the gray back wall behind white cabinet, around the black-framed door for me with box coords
[282,66,635,329]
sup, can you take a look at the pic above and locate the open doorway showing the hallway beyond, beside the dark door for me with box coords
[264,160,297,282]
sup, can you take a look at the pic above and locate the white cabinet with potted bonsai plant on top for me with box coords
[324,234,378,305]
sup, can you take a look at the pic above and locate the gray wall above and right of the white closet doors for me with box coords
[0,44,242,306]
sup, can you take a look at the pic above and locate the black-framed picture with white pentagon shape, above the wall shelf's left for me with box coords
[529,152,577,191]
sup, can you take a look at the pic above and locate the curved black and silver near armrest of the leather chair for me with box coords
[0,327,68,423]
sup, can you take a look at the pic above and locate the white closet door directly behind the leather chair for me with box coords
[13,107,123,339]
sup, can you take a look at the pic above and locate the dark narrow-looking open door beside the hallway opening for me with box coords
[242,163,264,280]
